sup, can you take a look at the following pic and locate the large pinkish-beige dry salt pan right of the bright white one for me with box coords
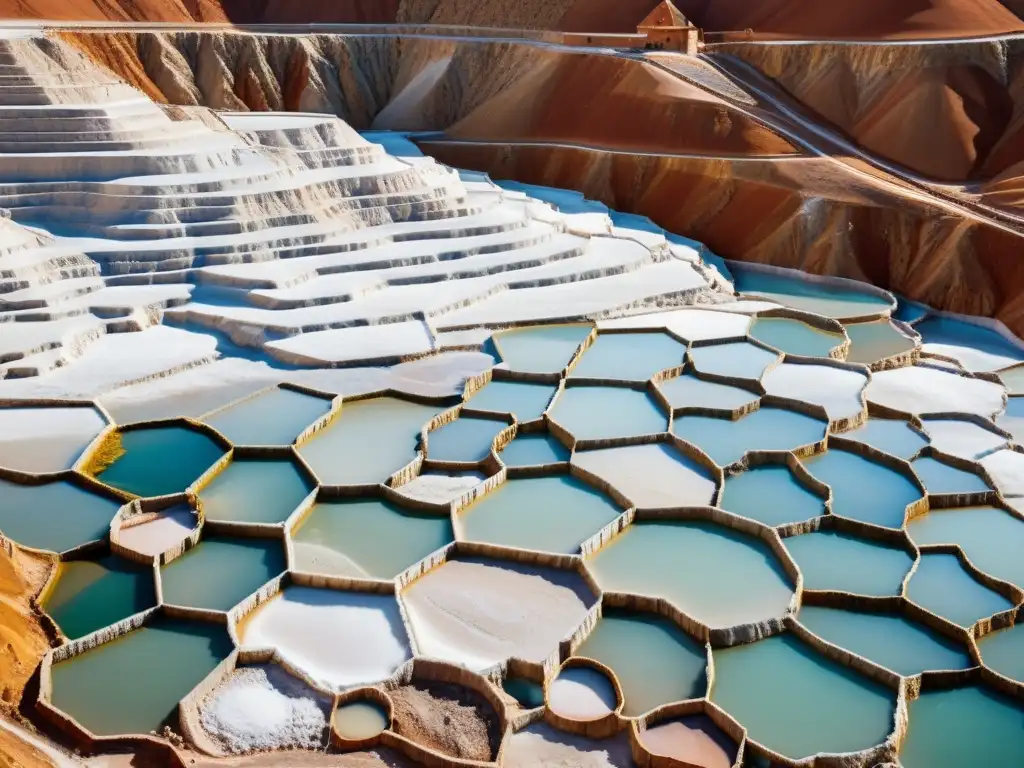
[400,557,597,670]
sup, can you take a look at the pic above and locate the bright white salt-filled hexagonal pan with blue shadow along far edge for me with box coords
[239,586,413,690]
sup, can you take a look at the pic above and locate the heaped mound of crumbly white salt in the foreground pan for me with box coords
[200,666,331,754]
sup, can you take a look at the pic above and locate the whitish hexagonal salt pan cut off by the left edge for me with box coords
[0,408,106,472]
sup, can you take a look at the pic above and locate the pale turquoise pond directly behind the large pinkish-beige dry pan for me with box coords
[459,475,623,554]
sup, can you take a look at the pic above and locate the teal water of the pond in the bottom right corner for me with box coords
[899,686,1024,768]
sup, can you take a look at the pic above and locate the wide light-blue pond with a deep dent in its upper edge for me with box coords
[672,408,827,467]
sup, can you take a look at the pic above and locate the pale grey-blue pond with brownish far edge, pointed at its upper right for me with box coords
[299,397,444,485]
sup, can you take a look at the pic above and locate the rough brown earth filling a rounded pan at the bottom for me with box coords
[390,683,501,761]
